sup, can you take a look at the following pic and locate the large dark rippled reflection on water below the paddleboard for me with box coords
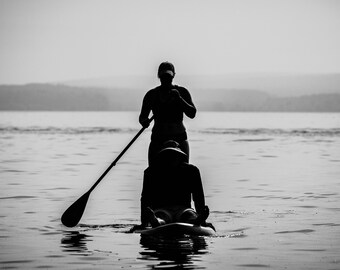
[140,235,208,269]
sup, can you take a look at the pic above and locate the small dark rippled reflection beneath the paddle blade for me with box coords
[61,231,92,255]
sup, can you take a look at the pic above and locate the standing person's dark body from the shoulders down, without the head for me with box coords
[139,85,196,165]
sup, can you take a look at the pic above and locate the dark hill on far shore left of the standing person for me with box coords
[0,84,143,111]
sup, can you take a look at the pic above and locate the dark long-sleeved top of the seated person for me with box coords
[141,163,205,224]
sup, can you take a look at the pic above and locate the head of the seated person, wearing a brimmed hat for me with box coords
[156,140,188,167]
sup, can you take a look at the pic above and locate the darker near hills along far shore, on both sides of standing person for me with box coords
[0,84,340,112]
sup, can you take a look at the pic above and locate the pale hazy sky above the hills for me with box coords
[0,0,340,84]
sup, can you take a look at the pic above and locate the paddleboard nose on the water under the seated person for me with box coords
[134,223,216,236]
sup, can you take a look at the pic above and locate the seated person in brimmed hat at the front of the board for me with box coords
[141,140,209,227]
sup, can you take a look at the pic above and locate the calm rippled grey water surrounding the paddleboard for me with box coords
[0,112,340,269]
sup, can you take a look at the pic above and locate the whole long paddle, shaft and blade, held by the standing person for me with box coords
[61,116,153,227]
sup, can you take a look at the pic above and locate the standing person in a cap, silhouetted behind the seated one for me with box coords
[139,62,196,165]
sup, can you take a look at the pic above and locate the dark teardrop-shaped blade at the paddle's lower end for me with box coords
[61,192,90,227]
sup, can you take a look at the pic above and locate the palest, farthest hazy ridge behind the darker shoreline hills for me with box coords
[61,73,340,97]
